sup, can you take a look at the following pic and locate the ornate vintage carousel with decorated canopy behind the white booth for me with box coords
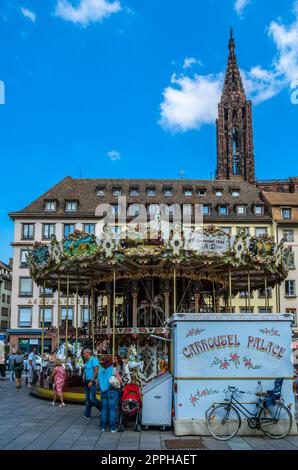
[29,218,290,401]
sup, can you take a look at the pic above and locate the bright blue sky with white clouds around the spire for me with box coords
[0,0,298,261]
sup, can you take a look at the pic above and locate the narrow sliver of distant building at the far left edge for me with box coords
[0,261,12,333]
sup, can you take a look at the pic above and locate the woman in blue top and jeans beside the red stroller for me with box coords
[98,358,122,432]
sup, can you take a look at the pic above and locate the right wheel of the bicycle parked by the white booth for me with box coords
[259,403,293,439]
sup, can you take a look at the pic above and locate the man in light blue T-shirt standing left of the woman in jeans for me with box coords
[82,349,101,419]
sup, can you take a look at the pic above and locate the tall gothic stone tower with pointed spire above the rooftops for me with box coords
[216,30,255,183]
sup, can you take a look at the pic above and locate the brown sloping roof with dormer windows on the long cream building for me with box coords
[10,176,271,222]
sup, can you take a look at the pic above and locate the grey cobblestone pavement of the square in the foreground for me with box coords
[0,380,298,451]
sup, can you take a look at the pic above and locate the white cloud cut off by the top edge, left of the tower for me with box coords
[55,0,121,26]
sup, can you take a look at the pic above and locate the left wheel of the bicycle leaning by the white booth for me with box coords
[207,405,241,441]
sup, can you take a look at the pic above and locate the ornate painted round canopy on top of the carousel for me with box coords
[28,223,291,294]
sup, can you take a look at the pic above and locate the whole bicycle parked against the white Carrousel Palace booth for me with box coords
[206,386,293,441]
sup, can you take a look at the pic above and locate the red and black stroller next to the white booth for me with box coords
[118,383,142,432]
